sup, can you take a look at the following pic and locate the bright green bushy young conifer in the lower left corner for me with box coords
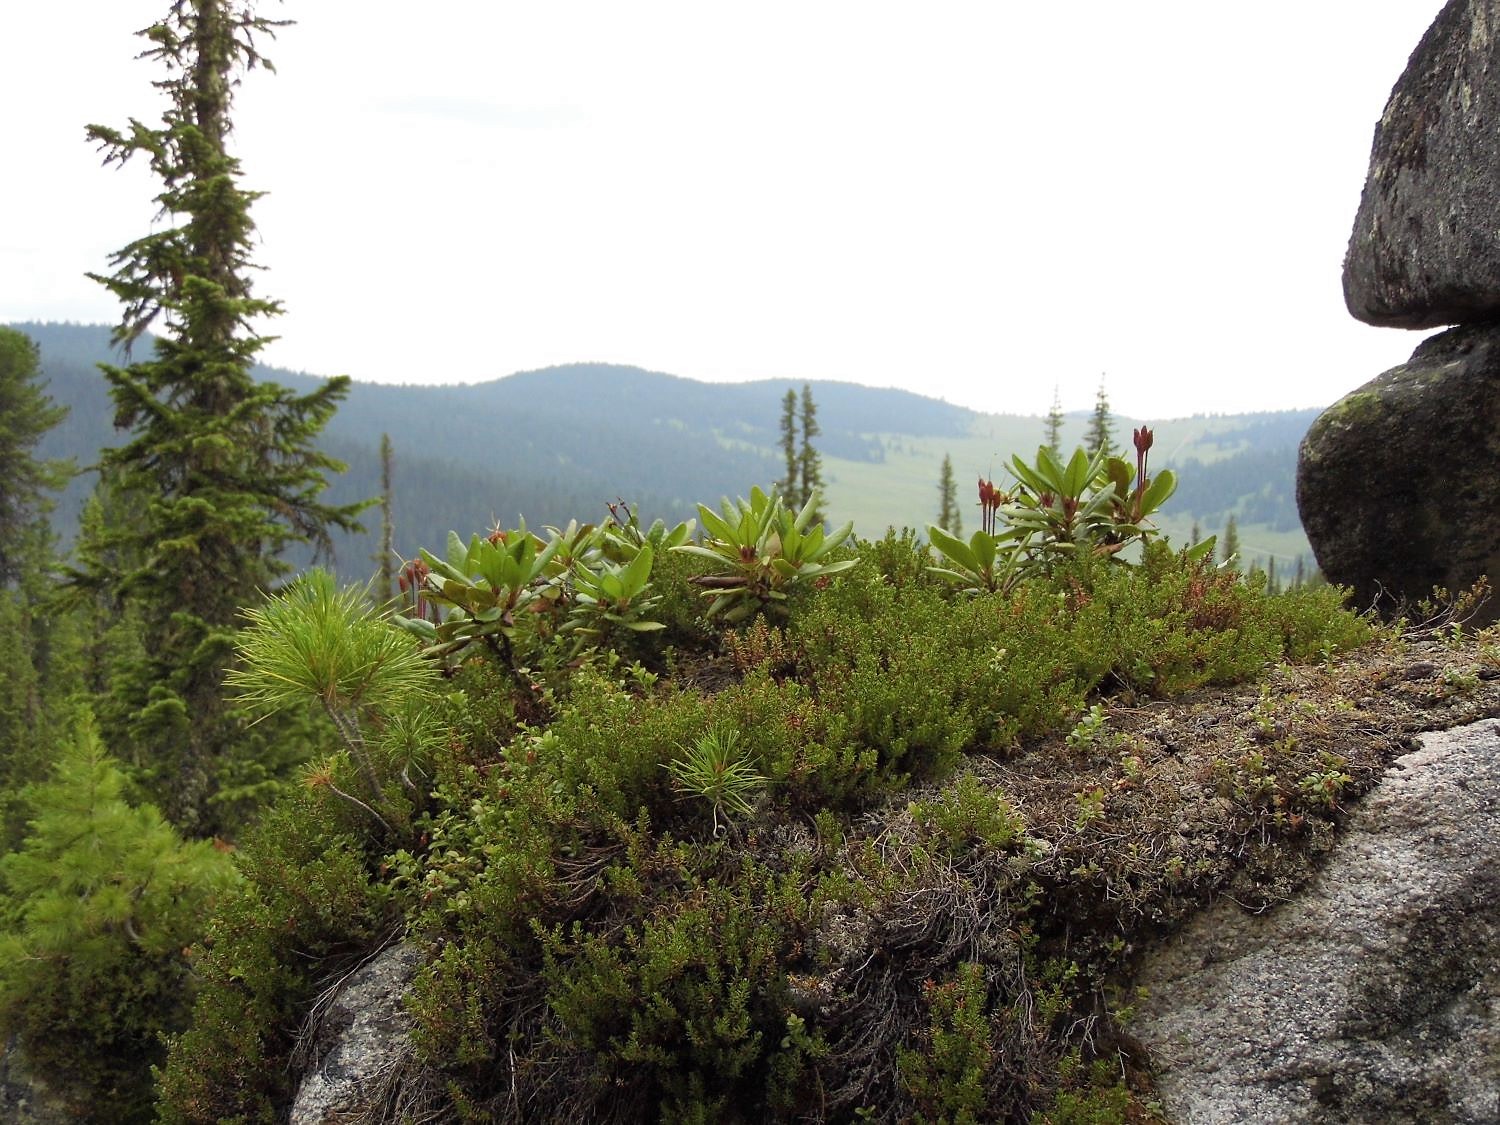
[0,716,237,1121]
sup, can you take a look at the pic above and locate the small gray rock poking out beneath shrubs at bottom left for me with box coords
[291,945,422,1125]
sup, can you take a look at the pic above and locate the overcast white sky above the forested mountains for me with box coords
[0,0,1442,417]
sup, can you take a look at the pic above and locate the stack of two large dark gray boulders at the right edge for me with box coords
[1298,0,1500,620]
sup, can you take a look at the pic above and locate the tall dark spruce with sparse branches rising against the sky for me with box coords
[78,0,360,834]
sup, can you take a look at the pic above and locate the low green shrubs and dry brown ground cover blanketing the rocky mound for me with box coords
[149,536,1500,1124]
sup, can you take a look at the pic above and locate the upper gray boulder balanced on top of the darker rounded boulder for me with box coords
[1344,0,1500,329]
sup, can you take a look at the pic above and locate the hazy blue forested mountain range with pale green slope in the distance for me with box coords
[11,324,1317,578]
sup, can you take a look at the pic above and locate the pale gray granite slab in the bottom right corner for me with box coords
[1131,720,1500,1125]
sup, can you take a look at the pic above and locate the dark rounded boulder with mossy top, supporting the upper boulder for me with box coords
[1298,326,1500,620]
